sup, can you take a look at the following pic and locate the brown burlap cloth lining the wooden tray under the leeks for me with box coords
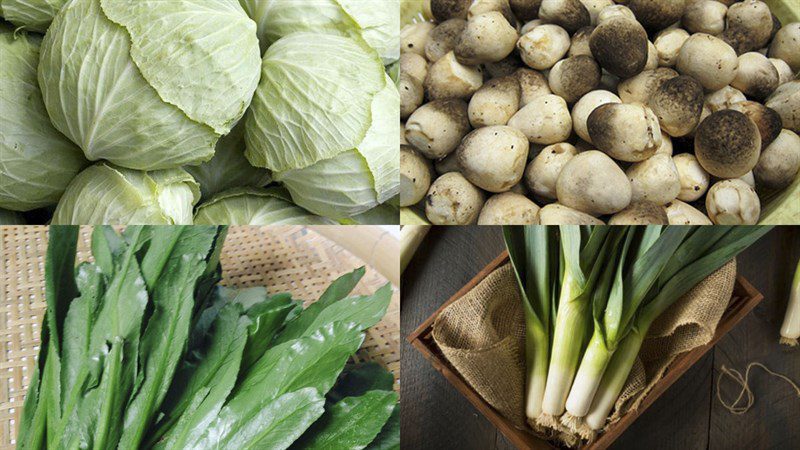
[433,260,736,436]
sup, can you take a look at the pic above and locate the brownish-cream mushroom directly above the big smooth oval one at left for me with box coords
[468,75,520,128]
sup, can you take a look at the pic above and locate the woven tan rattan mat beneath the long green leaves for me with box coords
[0,226,400,450]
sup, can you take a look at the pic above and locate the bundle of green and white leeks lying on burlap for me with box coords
[504,226,769,439]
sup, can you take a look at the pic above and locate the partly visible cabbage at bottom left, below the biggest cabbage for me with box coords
[53,163,200,225]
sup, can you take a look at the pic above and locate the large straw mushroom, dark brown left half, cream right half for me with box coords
[586,103,661,162]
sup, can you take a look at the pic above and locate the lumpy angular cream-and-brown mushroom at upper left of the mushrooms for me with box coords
[424,52,483,100]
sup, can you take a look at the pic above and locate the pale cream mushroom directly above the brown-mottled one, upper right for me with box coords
[675,33,739,91]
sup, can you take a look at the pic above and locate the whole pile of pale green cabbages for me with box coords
[0,0,400,224]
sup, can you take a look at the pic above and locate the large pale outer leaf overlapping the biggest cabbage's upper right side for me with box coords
[102,0,261,135]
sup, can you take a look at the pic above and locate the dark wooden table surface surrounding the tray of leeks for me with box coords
[400,226,800,450]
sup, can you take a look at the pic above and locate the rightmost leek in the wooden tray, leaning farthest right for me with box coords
[585,226,771,430]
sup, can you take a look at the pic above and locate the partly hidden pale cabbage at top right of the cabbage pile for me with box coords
[240,0,400,64]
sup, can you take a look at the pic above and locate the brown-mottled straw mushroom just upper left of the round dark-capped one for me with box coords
[648,75,705,137]
